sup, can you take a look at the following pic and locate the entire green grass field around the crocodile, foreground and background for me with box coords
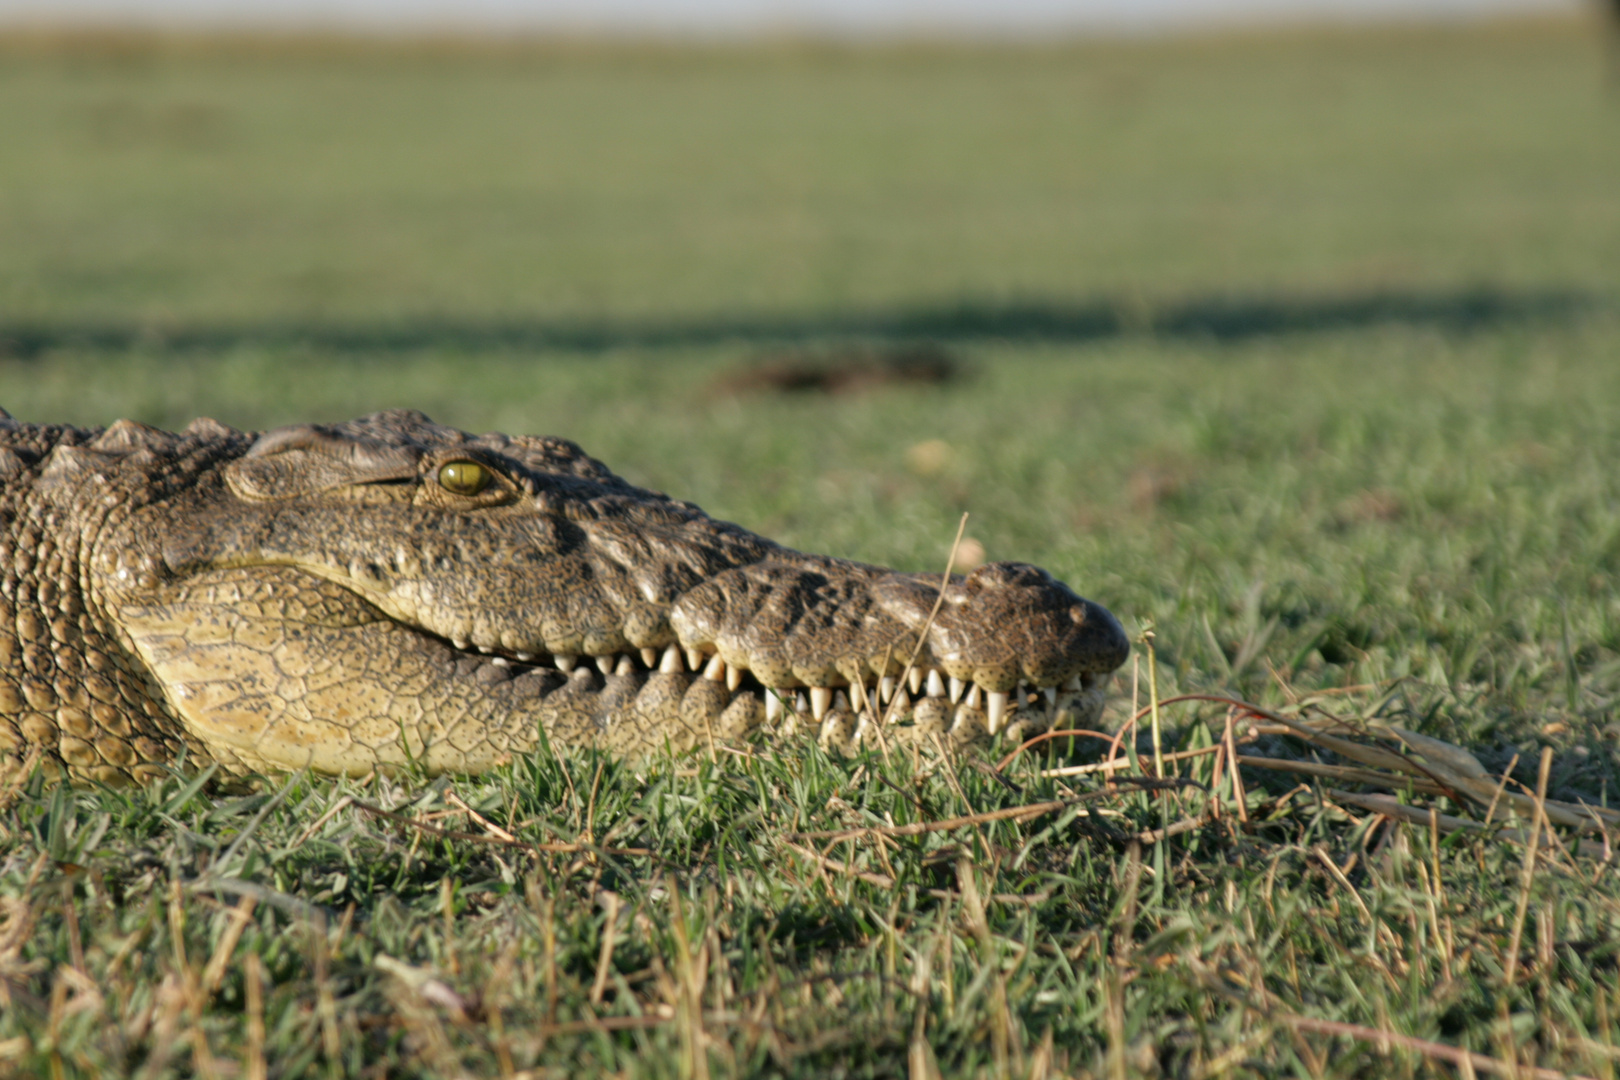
[0,24,1620,1080]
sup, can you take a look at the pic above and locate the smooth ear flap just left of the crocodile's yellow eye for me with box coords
[225,424,421,502]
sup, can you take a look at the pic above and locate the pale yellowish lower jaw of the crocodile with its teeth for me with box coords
[118,565,1111,776]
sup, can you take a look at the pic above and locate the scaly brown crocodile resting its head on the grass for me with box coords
[0,410,1129,784]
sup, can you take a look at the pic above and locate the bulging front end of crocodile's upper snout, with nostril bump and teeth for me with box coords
[657,552,1129,733]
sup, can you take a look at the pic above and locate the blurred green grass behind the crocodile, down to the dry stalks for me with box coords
[0,23,1620,761]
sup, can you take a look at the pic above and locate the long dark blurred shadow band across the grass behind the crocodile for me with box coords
[0,288,1609,359]
